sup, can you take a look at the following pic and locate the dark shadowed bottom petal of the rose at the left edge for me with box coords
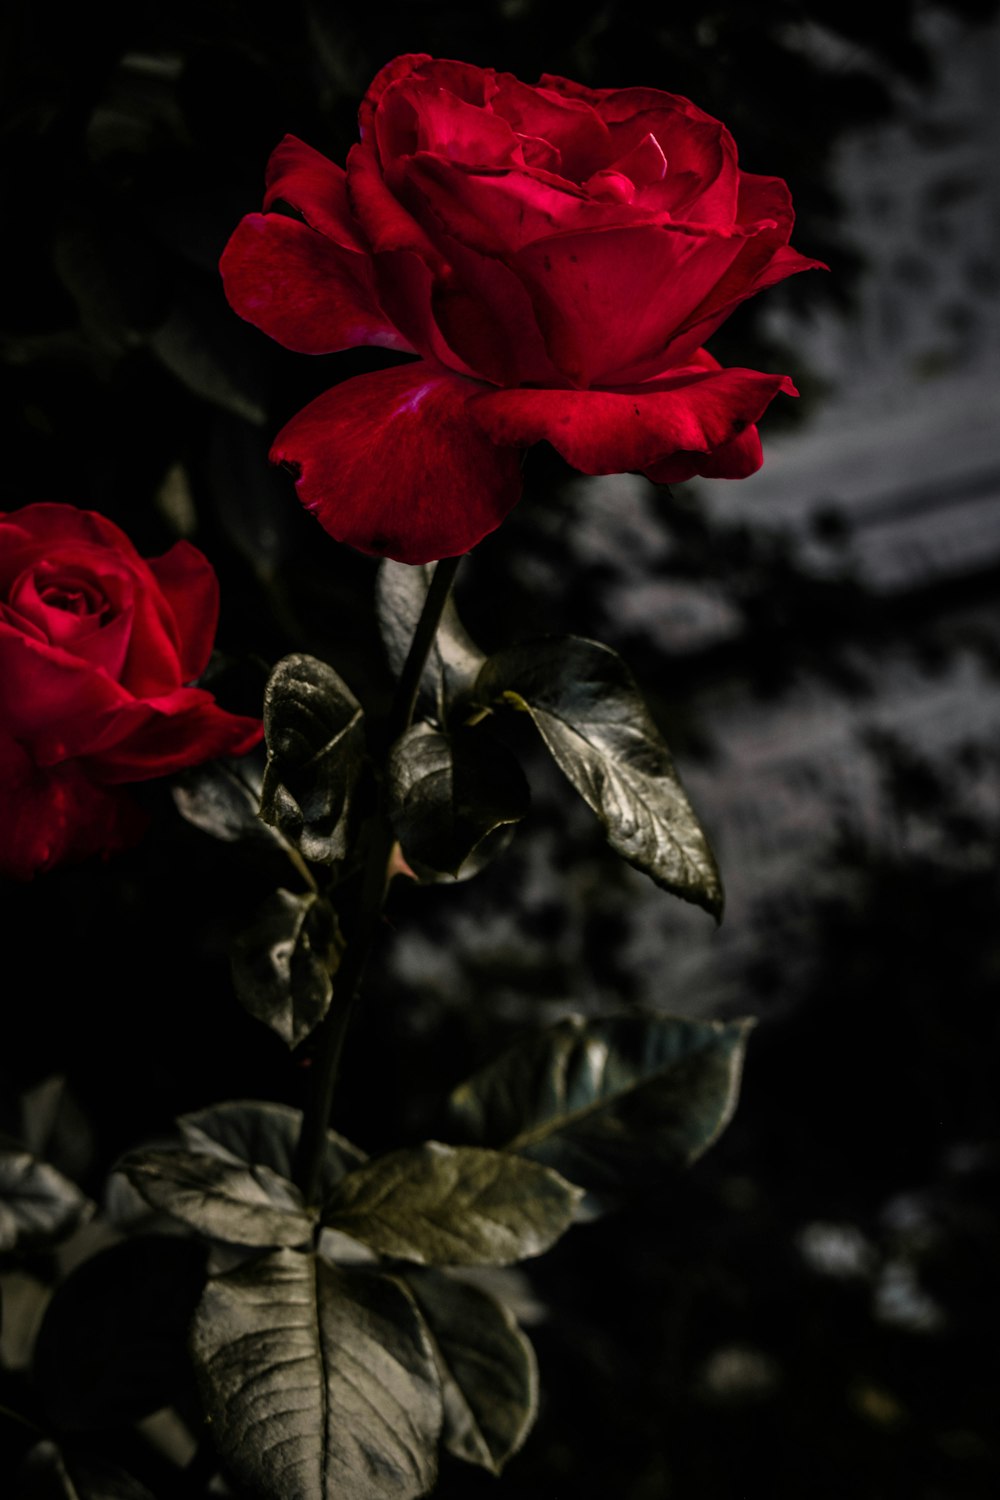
[0,737,147,881]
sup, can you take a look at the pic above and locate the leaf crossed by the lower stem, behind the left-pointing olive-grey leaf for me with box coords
[177,1100,366,1193]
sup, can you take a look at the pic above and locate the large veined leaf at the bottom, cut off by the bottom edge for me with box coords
[192,1250,441,1500]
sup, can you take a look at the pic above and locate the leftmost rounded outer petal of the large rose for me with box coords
[219,213,412,354]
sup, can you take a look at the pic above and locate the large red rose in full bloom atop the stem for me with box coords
[220,56,822,563]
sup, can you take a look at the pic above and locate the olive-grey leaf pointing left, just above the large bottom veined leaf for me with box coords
[117,1151,315,1247]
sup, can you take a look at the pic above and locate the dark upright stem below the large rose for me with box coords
[295,558,462,1203]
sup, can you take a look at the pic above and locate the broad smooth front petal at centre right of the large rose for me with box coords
[511,225,742,386]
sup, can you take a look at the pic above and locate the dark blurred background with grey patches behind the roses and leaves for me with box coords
[0,0,1000,1500]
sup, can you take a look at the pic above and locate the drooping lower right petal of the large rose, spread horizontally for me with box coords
[469,356,796,474]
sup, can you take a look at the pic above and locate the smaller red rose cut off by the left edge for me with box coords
[0,506,262,879]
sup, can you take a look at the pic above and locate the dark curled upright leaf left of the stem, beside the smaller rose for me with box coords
[261,654,364,864]
